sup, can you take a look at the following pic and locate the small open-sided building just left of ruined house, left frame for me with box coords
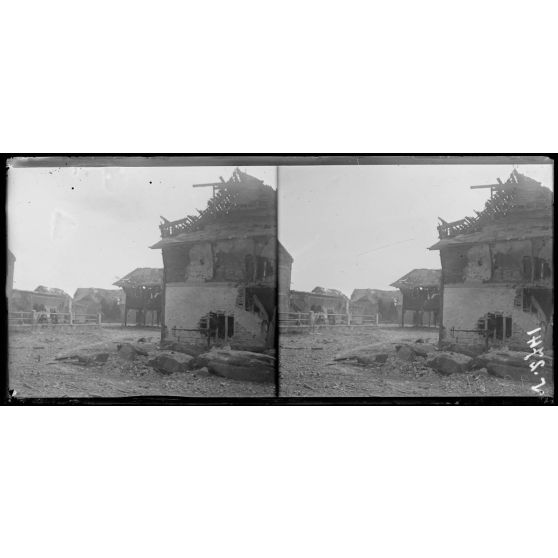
[114,267,163,326]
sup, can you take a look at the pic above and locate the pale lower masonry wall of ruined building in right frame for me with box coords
[443,285,540,345]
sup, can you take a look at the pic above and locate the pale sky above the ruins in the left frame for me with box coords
[7,167,276,296]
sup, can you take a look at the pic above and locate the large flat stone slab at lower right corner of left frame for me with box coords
[196,349,275,383]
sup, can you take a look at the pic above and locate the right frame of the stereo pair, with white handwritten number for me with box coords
[278,164,554,398]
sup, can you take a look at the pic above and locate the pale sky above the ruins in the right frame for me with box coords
[278,165,552,296]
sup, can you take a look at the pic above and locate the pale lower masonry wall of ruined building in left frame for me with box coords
[165,283,266,348]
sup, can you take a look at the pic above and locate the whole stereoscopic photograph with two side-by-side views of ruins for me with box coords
[6,157,554,403]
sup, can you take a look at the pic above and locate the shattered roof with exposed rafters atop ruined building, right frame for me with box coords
[438,169,553,240]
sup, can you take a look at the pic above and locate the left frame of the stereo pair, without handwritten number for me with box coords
[6,164,278,398]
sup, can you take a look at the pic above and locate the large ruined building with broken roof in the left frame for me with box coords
[152,169,277,350]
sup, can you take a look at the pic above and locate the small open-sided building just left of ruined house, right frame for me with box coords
[390,269,442,327]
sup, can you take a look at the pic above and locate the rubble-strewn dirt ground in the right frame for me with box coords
[279,326,552,397]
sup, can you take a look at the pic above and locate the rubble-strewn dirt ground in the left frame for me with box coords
[8,327,275,397]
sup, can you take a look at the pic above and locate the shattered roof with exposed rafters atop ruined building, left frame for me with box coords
[155,168,277,243]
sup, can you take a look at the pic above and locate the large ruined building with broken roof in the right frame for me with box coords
[430,170,553,351]
